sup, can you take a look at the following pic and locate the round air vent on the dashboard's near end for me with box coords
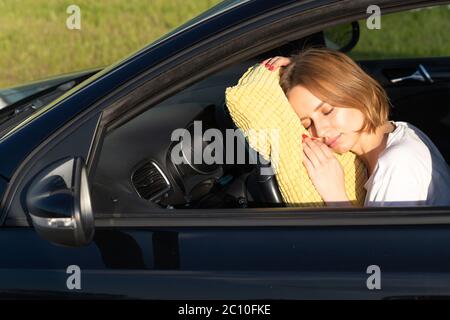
[131,161,170,202]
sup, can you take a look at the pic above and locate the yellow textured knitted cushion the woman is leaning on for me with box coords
[226,65,367,207]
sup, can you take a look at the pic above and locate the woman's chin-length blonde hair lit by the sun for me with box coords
[280,48,389,133]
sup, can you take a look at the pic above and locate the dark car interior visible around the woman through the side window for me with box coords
[91,12,450,214]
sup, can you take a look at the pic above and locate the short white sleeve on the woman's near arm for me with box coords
[366,156,431,207]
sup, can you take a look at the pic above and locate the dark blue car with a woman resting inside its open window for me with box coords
[0,0,450,300]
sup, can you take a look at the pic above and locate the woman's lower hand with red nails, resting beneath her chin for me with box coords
[303,135,351,206]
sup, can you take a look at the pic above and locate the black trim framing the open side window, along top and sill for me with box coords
[6,0,450,227]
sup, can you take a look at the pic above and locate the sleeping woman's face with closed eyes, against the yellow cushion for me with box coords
[287,85,364,153]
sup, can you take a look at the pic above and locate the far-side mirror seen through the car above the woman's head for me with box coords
[323,21,360,53]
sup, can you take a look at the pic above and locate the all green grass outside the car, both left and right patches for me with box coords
[0,0,450,88]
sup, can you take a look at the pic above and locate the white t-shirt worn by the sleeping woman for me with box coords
[364,121,450,207]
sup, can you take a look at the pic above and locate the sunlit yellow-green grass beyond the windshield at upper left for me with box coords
[0,0,220,87]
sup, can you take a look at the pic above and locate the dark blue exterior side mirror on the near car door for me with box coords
[26,158,95,246]
